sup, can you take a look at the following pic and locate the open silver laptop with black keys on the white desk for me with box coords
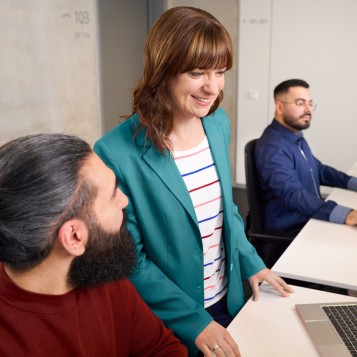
[295,301,357,357]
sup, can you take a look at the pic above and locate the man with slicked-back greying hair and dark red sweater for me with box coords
[0,134,187,357]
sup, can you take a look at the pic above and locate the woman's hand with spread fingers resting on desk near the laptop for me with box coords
[248,268,294,301]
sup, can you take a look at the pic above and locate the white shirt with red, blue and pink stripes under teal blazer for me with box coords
[174,137,227,308]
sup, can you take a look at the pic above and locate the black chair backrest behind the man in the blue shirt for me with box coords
[244,139,264,232]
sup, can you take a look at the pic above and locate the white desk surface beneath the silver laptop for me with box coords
[227,285,357,357]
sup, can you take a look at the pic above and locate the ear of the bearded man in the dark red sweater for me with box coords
[57,219,88,256]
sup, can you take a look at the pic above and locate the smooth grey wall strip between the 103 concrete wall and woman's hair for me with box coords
[97,0,148,133]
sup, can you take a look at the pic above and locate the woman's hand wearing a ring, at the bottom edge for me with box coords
[195,321,240,357]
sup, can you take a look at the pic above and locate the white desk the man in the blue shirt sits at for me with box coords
[272,163,357,290]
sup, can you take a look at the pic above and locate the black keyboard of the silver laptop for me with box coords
[322,304,357,357]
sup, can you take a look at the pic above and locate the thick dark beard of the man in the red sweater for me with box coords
[67,216,137,288]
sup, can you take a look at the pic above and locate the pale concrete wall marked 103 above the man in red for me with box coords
[0,0,101,145]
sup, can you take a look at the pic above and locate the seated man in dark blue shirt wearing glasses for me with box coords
[255,79,357,264]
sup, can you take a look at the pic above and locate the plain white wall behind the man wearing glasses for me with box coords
[236,0,357,186]
